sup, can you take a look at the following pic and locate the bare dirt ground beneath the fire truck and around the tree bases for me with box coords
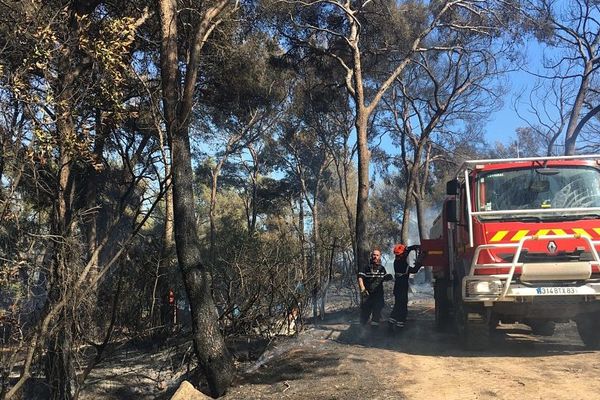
[86,282,600,400]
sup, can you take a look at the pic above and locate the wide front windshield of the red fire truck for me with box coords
[476,167,600,219]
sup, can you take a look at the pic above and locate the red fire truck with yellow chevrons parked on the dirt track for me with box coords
[421,155,600,349]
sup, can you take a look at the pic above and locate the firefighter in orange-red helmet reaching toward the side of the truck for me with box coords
[389,244,420,328]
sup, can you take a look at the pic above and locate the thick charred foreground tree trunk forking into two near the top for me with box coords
[158,0,233,397]
